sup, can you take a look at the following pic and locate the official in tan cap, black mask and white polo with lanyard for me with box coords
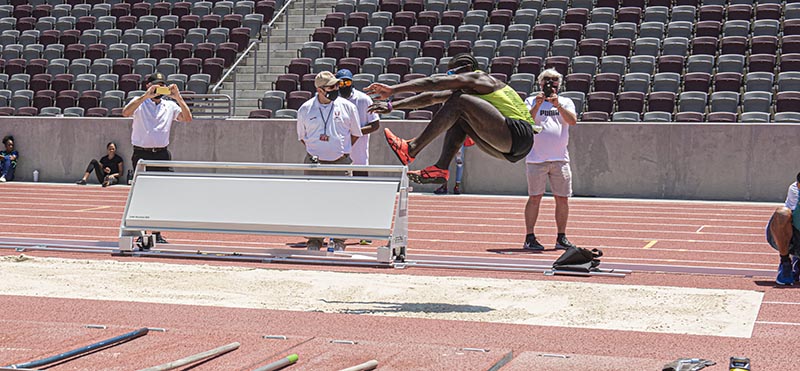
[297,71,361,251]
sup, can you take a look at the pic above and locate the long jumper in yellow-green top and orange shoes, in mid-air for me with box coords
[364,53,541,183]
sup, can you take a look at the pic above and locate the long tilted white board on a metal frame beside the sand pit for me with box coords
[120,161,408,262]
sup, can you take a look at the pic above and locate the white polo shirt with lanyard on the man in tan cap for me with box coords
[297,95,361,161]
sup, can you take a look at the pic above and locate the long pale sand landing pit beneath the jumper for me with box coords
[0,255,763,337]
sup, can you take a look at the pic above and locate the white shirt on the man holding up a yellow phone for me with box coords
[131,99,181,148]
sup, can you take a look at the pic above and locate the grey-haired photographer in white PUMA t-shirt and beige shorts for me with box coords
[523,68,578,251]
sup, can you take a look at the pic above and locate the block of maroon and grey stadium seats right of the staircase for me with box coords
[252,0,800,122]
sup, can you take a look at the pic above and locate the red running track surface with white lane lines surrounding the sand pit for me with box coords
[0,183,800,371]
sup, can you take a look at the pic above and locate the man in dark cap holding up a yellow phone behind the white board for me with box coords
[122,72,192,247]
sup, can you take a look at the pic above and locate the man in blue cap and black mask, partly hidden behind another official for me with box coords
[336,68,381,176]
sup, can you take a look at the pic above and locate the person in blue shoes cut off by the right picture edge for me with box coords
[767,173,800,286]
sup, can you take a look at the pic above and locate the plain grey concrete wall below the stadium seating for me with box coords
[0,117,800,202]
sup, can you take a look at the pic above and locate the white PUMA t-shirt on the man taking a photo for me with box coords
[525,95,575,164]
